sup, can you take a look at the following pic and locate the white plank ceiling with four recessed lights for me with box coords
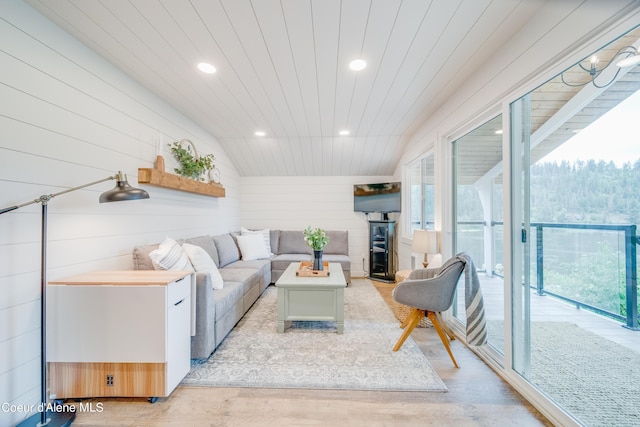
[27,0,540,176]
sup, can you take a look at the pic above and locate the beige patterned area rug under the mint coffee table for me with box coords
[182,279,447,392]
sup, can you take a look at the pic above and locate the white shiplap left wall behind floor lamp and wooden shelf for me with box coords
[0,1,239,426]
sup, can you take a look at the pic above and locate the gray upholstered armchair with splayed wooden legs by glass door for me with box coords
[392,257,465,368]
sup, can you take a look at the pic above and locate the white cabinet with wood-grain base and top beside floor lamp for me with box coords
[47,271,193,398]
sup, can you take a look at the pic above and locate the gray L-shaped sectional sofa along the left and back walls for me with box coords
[133,230,351,359]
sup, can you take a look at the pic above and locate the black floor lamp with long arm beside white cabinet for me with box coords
[0,172,149,426]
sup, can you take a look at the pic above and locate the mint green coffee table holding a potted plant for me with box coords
[276,262,347,334]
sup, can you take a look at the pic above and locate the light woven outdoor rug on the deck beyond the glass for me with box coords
[487,321,640,427]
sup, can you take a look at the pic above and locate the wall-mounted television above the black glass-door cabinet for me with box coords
[353,182,402,213]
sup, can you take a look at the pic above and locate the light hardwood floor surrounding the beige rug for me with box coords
[67,282,551,427]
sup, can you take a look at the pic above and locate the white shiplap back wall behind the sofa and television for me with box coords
[240,176,399,277]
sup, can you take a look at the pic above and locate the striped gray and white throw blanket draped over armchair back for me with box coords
[457,252,487,346]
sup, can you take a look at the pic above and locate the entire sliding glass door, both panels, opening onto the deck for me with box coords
[440,24,640,426]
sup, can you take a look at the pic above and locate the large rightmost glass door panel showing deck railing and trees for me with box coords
[508,25,640,426]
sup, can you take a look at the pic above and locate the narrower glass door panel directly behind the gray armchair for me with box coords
[452,115,504,353]
